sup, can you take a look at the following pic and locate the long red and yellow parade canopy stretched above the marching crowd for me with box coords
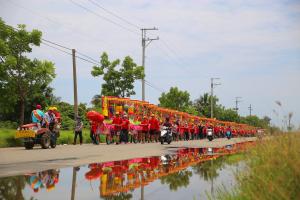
[102,96,256,129]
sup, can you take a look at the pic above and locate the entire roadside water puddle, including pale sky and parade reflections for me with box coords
[0,142,254,200]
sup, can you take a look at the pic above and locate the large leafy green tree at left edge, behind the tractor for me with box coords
[0,18,55,125]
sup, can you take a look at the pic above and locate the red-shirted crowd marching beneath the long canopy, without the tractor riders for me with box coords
[90,112,256,144]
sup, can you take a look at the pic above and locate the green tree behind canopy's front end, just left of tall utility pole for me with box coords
[91,52,145,97]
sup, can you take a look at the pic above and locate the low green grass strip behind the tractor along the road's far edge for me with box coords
[0,128,105,147]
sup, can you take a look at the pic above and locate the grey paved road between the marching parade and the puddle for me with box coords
[0,138,255,177]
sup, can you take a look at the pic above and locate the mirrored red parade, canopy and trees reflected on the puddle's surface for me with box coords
[0,142,254,199]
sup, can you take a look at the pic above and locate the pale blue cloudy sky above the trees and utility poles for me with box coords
[0,0,300,127]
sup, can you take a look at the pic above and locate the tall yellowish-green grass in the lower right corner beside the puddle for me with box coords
[216,133,300,200]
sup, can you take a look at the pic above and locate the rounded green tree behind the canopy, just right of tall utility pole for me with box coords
[159,87,192,111]
